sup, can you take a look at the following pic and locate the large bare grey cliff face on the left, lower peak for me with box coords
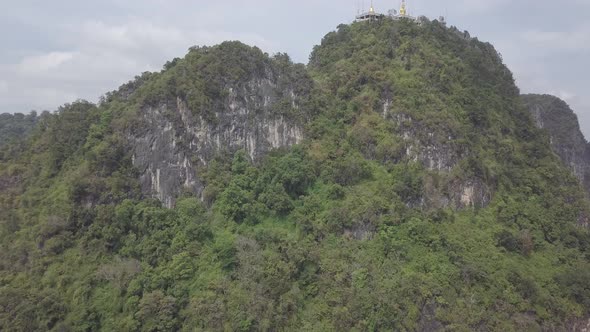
[128,75,303,207]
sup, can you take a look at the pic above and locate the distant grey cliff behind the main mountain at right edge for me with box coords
[522,95,590,192]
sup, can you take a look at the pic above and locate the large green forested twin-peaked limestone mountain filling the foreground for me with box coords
[0,18,590,331]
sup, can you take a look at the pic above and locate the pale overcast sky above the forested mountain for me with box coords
[0,0,590,137]
